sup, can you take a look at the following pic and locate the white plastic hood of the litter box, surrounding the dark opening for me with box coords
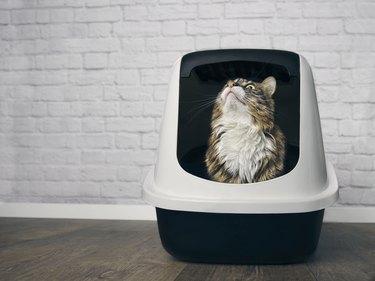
[143,50,338,214]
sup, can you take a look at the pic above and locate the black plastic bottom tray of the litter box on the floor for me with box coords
[156,208,324,264]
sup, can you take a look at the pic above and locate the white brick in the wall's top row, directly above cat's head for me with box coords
[225,2,276,18]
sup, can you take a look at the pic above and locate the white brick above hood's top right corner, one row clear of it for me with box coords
[265,19,316,35]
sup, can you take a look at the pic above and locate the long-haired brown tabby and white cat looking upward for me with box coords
[205,76,285,183]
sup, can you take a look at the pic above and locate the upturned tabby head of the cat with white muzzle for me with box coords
[216,76,276,130]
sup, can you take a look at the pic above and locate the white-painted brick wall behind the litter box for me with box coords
[0,0,375,205]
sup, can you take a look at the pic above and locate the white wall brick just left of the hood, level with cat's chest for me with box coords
[106,118,155,132]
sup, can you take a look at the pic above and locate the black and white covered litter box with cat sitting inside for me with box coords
[143,49,338,264]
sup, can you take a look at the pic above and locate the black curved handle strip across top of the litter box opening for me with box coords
[180,49,299,77]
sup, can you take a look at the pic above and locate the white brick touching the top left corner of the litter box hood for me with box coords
[146,36,194,51]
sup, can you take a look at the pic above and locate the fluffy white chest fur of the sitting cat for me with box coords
[216,107,275,182]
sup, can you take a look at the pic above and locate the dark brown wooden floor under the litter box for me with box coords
[0,218,375,281]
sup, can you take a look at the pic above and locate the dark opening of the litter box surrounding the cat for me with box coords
[177,50,300,182]
